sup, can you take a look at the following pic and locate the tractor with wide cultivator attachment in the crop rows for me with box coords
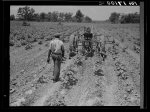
[69,27,115,59]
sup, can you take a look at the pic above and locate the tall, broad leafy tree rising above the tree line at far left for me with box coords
[17,6,35,21]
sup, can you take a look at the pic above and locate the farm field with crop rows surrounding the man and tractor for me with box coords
[9,21,140,106]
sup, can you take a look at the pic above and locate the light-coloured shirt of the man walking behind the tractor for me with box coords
[50,38,64,53]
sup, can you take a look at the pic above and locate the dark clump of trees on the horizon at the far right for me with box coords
[109,12,140,23]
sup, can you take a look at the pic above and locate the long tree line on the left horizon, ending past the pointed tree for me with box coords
[10,6,92,22]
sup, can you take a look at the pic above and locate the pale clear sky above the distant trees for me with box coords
[10,6,140,20]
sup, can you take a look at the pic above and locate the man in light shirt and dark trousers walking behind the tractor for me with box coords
[47,33,65,82]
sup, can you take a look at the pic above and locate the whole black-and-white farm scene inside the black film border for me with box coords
[8,1,143,107]
